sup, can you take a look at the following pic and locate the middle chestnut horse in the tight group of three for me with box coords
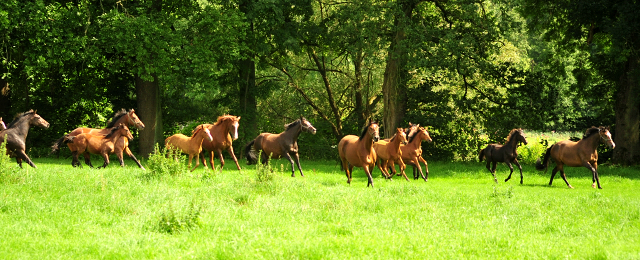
[373,128,409,181]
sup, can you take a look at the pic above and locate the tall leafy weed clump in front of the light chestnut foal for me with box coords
[143,144,189,178]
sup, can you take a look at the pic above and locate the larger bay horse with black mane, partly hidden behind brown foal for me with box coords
[51,108,144,157]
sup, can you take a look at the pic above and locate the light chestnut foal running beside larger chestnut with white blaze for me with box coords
[164,125,213,171]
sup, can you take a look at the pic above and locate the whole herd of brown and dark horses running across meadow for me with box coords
[0,109,615,189]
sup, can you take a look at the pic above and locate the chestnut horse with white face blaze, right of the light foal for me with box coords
[202,115,240,170]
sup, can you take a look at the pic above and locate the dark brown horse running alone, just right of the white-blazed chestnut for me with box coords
[244,116,316,177]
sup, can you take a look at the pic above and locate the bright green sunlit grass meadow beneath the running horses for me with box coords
[0,156,640,259]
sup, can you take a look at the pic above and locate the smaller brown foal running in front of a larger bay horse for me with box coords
[63,123,133,168]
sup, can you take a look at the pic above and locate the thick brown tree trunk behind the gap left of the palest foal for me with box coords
[136,74,163,157]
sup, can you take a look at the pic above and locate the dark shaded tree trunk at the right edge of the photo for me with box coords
[612,57,640,165]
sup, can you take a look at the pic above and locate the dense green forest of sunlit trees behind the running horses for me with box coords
[0,0,640,165]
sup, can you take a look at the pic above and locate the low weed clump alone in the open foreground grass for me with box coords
[155,203,202,234]
